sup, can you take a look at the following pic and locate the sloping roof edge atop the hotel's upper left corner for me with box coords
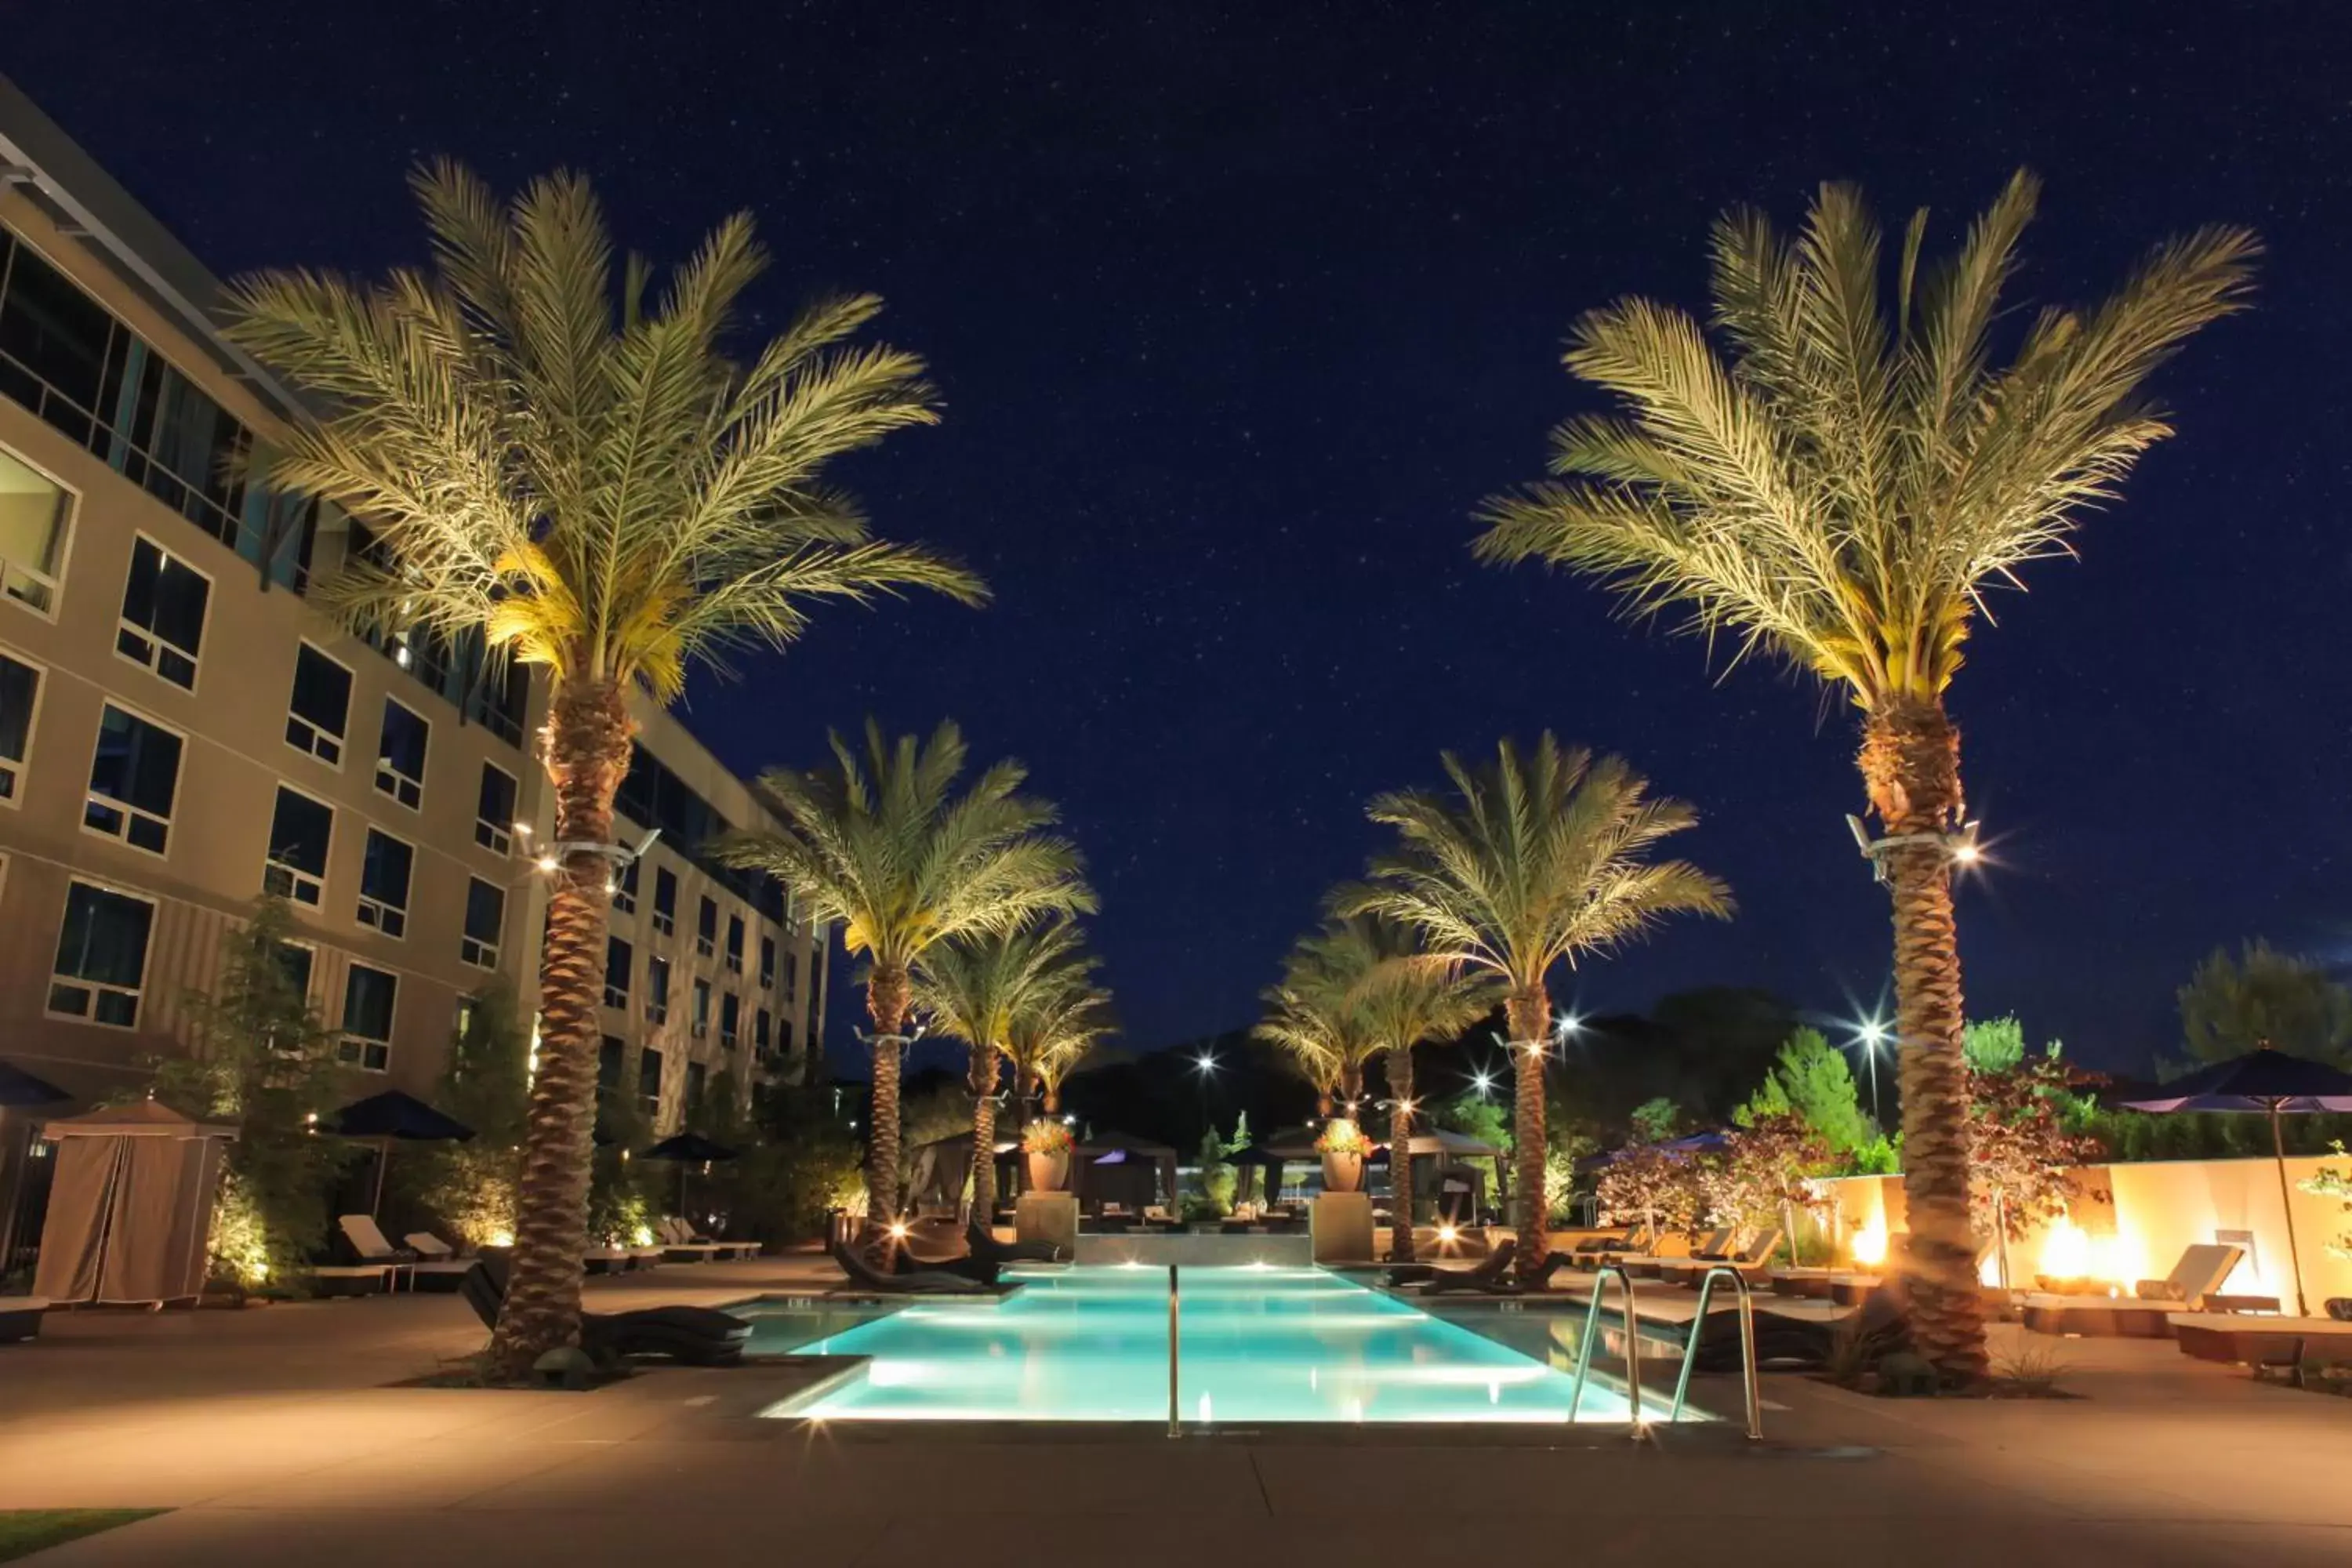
[0,75,301,419]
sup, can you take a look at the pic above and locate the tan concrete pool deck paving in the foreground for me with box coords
[0,1255,2352,1568]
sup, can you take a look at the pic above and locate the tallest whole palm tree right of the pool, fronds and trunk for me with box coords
[1477,172,2258,1377]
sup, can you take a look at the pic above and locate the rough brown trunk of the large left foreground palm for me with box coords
[489,682,635,1377]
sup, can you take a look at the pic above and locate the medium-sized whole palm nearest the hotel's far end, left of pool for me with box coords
[720,720,1094,1225]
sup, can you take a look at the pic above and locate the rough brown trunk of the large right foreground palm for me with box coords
[1860,701,1987,1382]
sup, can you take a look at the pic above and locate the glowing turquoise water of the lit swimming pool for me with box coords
[753,1267,1628,1425]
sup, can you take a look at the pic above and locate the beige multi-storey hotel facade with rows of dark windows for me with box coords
[0,80,826,1260]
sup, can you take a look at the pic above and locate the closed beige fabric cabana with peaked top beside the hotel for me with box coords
[33,1100,238,1305]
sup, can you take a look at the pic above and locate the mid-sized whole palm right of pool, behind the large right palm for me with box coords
[1334,734,1731,1276]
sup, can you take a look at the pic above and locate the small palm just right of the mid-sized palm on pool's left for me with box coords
[915,919,1094,1225]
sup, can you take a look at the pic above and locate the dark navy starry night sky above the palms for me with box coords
[0,0,2352,1081]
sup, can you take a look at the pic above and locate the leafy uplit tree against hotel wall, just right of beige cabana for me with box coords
[148,898,360,1286]
